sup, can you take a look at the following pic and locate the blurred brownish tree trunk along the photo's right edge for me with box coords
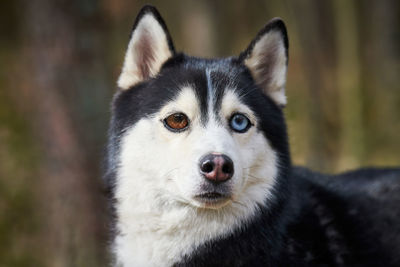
[360,0,400,165]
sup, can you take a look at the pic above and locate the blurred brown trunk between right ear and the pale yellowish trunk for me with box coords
[287,0,340,171]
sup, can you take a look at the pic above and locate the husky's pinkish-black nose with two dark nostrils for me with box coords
[200,153,234,183]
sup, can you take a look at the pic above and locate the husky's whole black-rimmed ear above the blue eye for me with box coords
[239,18,288,107]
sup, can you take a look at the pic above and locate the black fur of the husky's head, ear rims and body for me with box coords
[106,7,400,267]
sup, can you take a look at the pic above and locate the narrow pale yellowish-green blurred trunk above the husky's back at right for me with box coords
[333,0,364,169]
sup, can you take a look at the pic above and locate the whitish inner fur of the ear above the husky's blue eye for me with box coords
[245,31,287,106]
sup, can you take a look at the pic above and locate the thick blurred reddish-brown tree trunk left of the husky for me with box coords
[17,0,105,267]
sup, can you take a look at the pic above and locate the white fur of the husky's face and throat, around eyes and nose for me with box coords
[114,85,278,267]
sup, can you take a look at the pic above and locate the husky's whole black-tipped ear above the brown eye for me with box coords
[118,5,175,89]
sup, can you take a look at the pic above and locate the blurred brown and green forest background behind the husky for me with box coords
[0,0,400,267]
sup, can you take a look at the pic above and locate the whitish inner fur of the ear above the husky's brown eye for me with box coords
[118,13,172,89]
